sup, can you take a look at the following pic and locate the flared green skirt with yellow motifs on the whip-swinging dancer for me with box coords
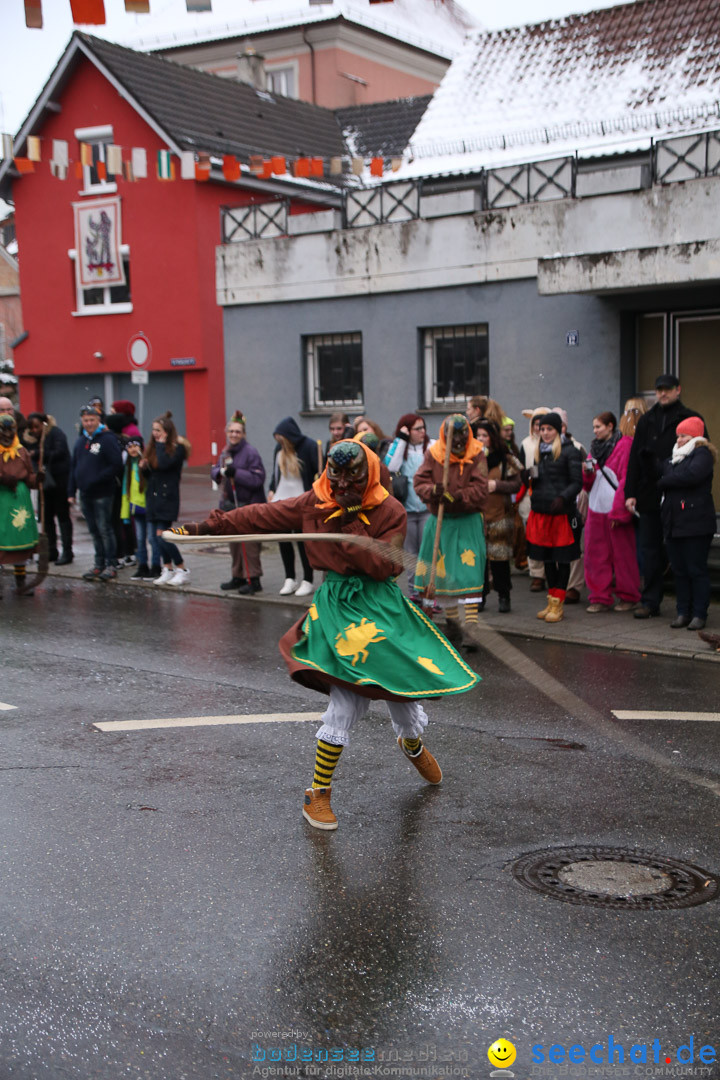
[290,570,479,698]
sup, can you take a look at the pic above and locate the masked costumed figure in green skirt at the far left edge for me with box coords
[0,413,38,595]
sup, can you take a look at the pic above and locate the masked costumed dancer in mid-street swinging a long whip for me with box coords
[174,441,478,829]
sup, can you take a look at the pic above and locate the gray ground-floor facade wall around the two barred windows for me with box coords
[225,279,621,464]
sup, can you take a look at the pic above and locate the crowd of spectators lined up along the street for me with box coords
[0,373,717,630]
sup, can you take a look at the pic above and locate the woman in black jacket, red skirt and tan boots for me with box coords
[526,413,583,622]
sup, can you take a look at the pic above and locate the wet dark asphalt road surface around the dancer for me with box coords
[0,580,720,1080]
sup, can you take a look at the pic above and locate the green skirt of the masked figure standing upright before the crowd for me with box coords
[415,514,486,599]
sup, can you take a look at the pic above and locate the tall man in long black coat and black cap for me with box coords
[625,372,708,619]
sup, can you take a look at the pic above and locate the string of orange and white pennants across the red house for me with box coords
[1,135,403,181]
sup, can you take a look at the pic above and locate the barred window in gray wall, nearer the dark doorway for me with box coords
[423,324,490,408]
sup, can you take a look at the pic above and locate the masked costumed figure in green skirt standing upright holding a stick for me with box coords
[412,414,488,643]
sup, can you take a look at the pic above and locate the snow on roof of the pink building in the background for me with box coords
[127,0,478,59]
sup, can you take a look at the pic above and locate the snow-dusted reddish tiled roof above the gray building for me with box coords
[402,0,720,176]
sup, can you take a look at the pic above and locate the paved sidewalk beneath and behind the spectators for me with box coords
[42,471,720,663]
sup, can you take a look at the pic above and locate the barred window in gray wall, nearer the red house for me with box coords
[303,334,363,409]
